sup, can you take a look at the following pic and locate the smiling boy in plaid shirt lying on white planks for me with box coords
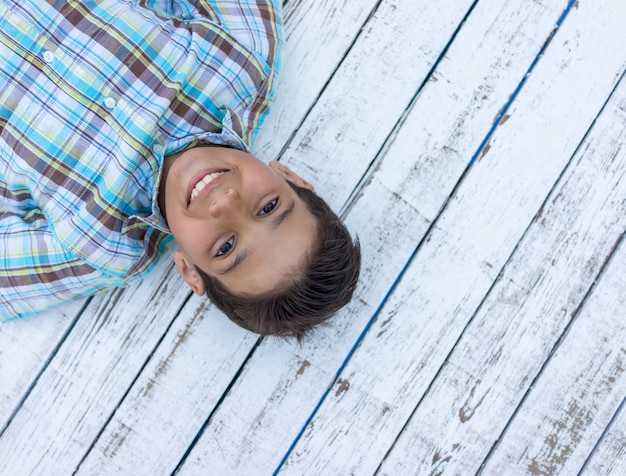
[0,0,360,338]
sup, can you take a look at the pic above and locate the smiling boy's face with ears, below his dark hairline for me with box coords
[159,146,315,294]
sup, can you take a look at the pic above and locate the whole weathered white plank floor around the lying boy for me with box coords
[0,0,626,476]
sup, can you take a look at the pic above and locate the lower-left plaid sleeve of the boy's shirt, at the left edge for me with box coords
[0,212,125,322]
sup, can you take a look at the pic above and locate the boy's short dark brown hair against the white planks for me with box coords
[196,182,361,340]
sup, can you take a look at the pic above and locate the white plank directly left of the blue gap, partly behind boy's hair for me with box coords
[172,2,580,474]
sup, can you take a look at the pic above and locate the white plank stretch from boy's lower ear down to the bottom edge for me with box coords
[76,295,258,475]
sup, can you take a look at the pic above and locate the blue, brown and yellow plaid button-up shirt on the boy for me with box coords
[0,0,281,321]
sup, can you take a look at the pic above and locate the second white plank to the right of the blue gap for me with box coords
[381,62,626,474]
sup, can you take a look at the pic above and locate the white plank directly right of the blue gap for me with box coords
[274,1,626,474]
